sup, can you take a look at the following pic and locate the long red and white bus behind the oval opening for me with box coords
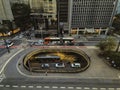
[44,37,74,45]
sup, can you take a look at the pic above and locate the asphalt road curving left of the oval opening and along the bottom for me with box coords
[0,38,120,90]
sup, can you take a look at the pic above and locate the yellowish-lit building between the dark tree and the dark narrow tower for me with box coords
[29,0,57,28]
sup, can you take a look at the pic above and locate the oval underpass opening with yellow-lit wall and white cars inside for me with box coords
[23,48,90,73]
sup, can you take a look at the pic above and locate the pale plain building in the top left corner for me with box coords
[0,0,14,22]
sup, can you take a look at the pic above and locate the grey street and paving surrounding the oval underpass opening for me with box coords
[0,36,120,90]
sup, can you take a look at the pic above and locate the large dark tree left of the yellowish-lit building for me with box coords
[12,3,31,30]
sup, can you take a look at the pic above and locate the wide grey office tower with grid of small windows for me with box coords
[69,0,118,33]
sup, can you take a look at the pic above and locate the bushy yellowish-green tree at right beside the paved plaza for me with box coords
[97,37,117,51]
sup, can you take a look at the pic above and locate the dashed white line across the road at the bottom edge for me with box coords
[0,85,120,90]
